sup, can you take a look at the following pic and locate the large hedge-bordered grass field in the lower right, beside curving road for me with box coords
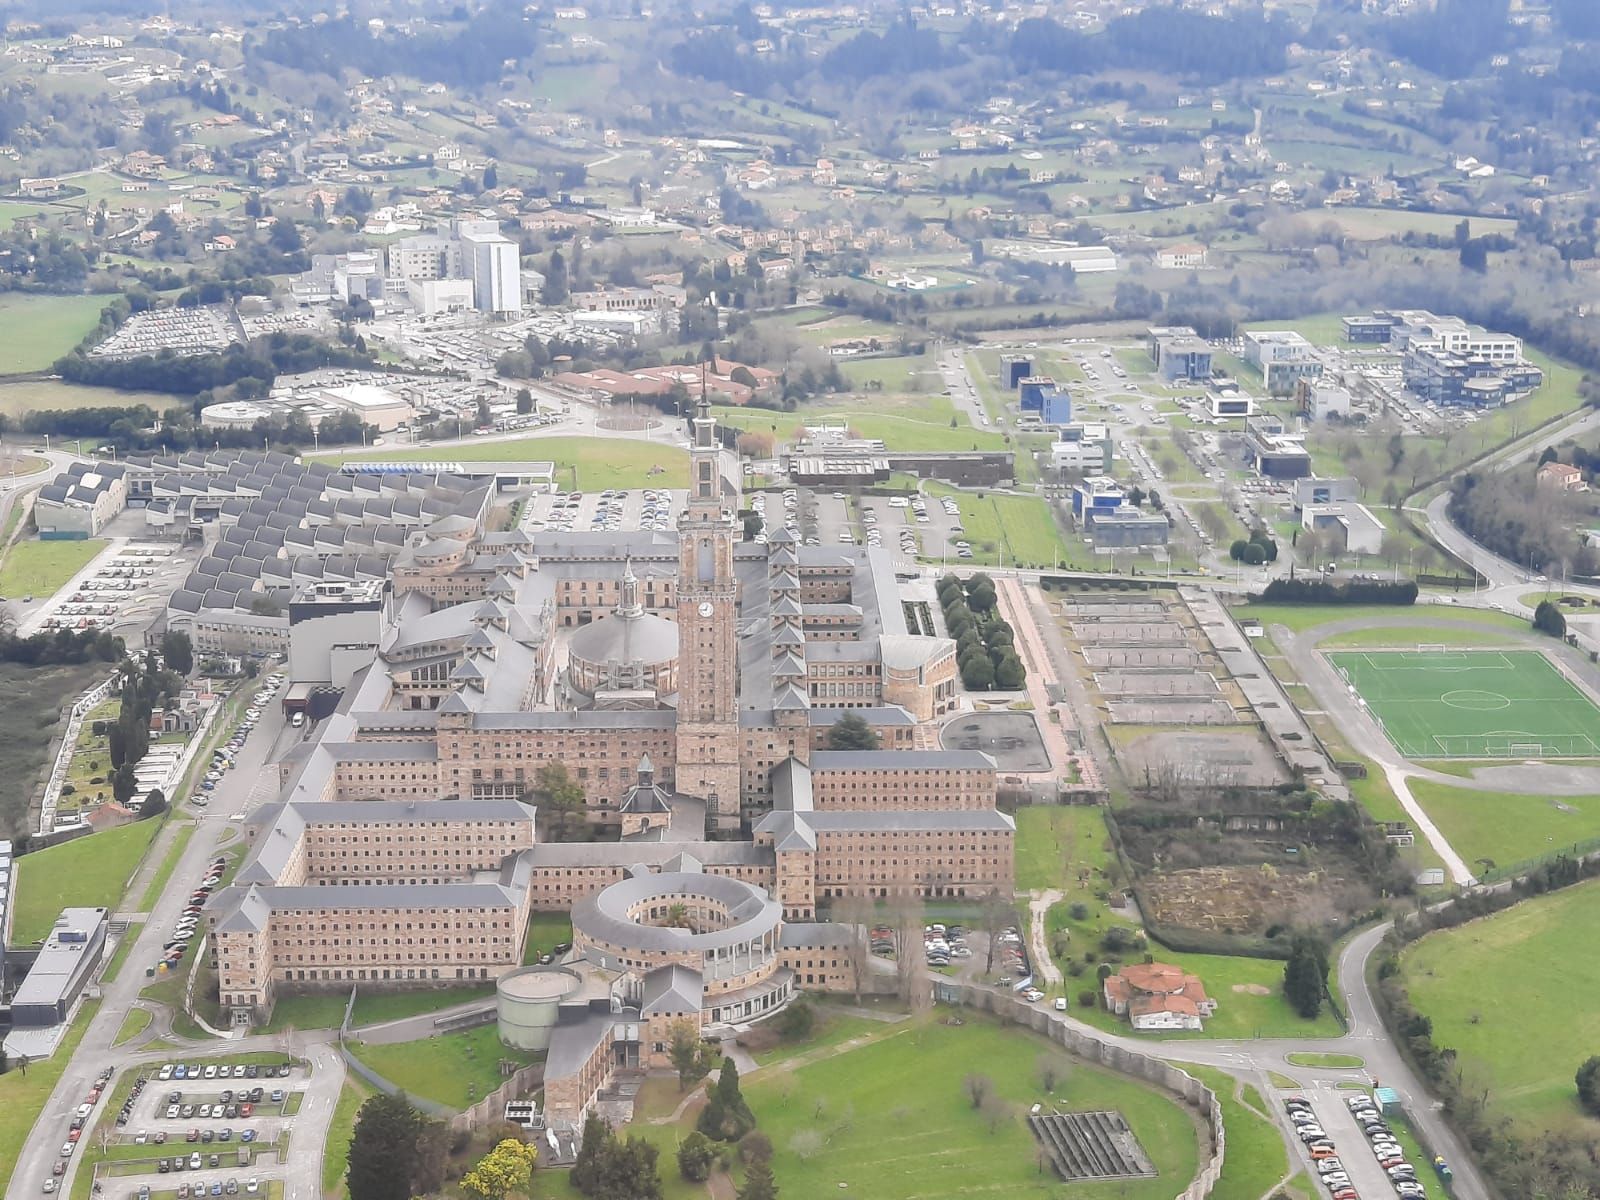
[1403,880,1600,1142]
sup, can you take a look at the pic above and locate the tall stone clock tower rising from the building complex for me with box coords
[675,398,741,832]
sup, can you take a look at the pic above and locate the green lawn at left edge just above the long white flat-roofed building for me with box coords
[11,818,162,946]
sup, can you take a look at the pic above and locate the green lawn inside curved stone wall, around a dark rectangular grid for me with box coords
[744,1011,1198,1200]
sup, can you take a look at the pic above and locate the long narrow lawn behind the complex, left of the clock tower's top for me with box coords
[307,437,690,491]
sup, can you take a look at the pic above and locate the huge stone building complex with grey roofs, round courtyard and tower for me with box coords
[208,403,1014,1088]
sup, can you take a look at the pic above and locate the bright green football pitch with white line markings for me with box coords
[1328,646,1600,758]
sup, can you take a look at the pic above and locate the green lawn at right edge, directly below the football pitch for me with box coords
[1411,779,1600,867]
